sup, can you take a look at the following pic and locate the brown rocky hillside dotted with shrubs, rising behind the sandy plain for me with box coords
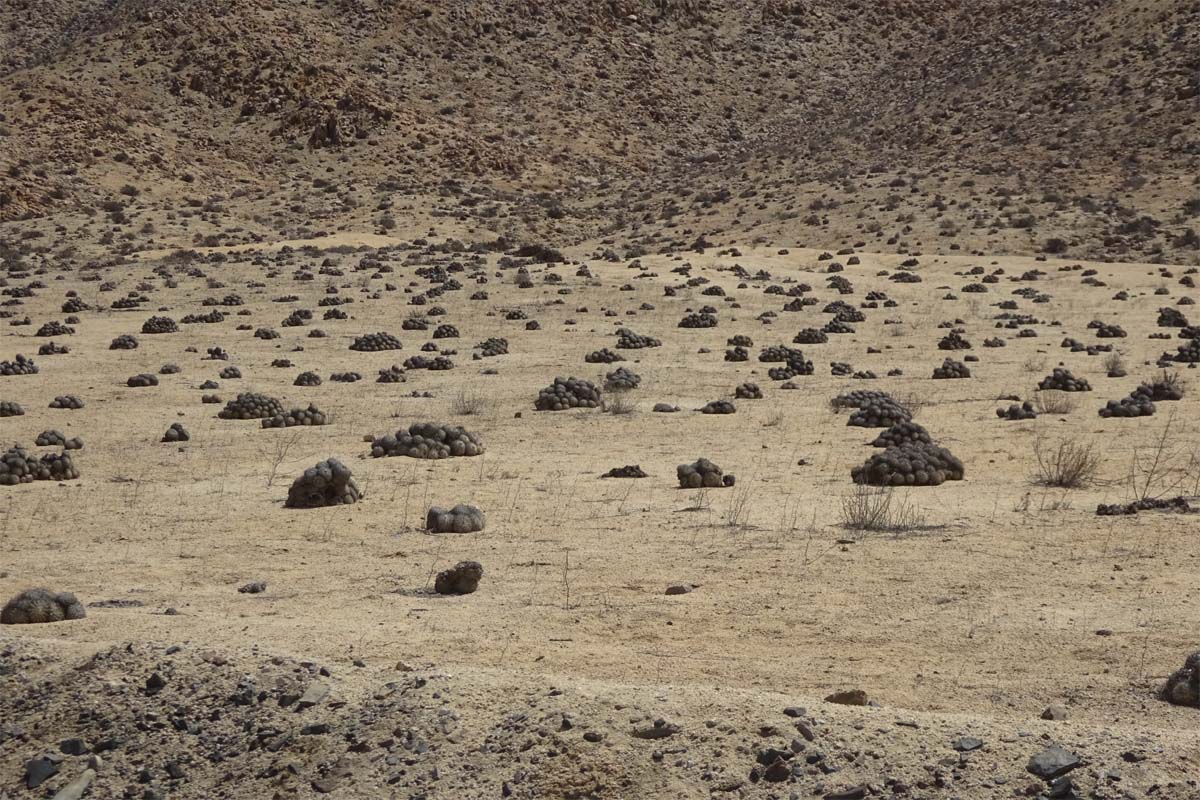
[0,0,1200,261]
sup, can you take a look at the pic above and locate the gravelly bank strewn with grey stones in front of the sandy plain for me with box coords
[0,640,1200,800]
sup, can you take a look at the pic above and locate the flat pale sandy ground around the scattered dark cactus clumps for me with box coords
[0,241,1200,798]
